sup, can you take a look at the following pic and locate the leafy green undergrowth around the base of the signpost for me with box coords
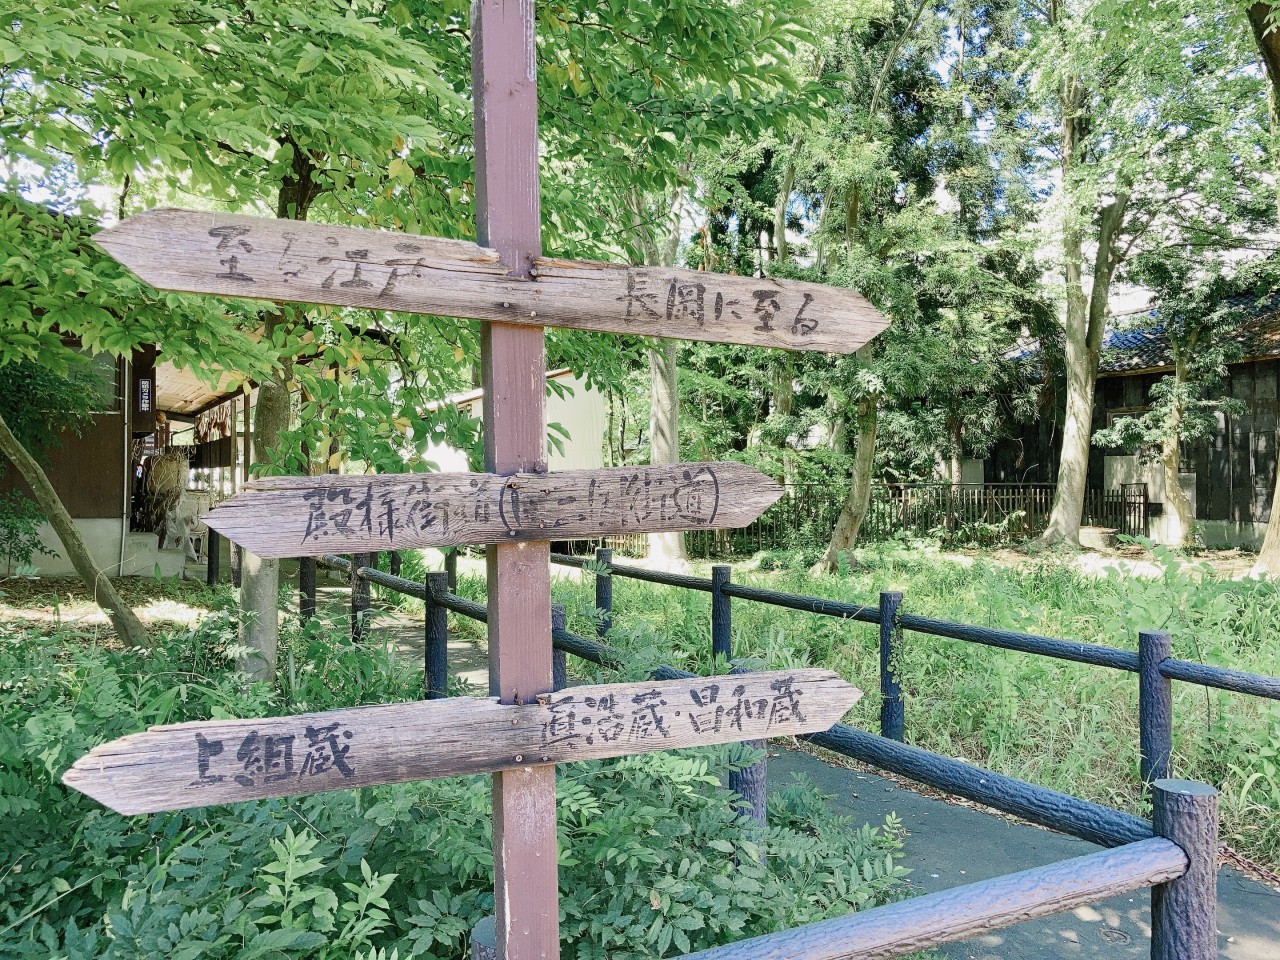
[0,609,904,960]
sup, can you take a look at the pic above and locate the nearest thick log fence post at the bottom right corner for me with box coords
[1151,780,1217,960]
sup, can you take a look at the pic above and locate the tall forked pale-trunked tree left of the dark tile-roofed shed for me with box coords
[1028,0,1265,545]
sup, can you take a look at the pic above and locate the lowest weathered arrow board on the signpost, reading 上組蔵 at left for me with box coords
[63,669,861,814]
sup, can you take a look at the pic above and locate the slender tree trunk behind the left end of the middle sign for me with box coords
[239,320,289,682]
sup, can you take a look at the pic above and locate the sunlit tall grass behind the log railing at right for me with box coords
[537,547,1280,869]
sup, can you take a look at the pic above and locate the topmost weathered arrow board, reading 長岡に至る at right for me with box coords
[95,209,888,353]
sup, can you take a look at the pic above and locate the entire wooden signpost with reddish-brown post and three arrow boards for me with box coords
[80,7,888,960]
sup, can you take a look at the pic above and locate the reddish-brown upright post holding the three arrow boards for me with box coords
[471,0,559,960]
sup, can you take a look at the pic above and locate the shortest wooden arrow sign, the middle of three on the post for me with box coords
[204,463,782,557]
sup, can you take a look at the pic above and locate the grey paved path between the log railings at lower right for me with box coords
[769,750,1280,960]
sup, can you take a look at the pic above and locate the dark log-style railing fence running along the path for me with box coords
[300,549,1280,960]
